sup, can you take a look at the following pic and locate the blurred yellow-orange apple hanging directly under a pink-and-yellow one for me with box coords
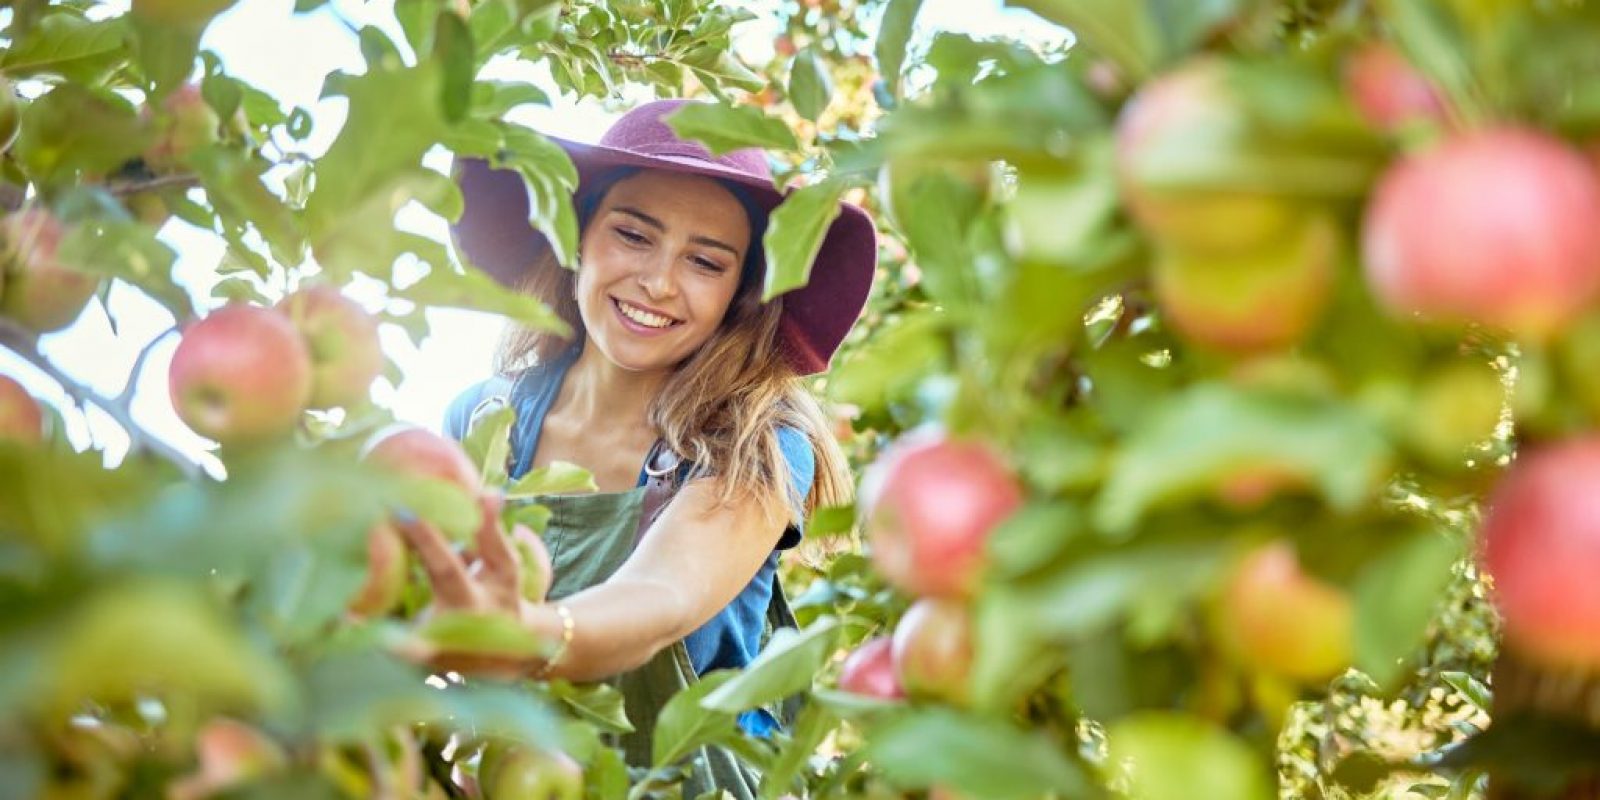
[1154,214,1339,352]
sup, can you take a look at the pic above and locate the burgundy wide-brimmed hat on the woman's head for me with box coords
[451,99,878,374]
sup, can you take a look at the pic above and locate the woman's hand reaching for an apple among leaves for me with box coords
[394,491,560,677]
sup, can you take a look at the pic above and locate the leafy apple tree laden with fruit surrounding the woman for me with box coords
[0,0,1600,800]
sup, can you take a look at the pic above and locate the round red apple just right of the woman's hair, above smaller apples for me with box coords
[862,435,1022,597]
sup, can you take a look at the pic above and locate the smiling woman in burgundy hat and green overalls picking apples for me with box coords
[396,101,877,797]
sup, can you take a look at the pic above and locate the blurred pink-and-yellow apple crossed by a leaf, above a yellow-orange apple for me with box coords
[1117,58,1299,253]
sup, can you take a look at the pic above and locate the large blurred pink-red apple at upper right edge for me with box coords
[1362,128,1600,339]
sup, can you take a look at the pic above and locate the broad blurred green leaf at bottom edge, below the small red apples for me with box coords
[866,709,1100,800]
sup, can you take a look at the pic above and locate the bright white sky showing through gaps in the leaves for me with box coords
[0,0,1064,469]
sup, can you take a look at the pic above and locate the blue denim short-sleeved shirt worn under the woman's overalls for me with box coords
[445,347,816,691]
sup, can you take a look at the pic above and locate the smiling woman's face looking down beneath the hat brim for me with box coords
[578,170,750,371]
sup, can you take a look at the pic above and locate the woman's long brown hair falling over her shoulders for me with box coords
[494,176,853,531]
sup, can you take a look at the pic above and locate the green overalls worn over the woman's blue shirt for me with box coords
[515,486,792,800]
